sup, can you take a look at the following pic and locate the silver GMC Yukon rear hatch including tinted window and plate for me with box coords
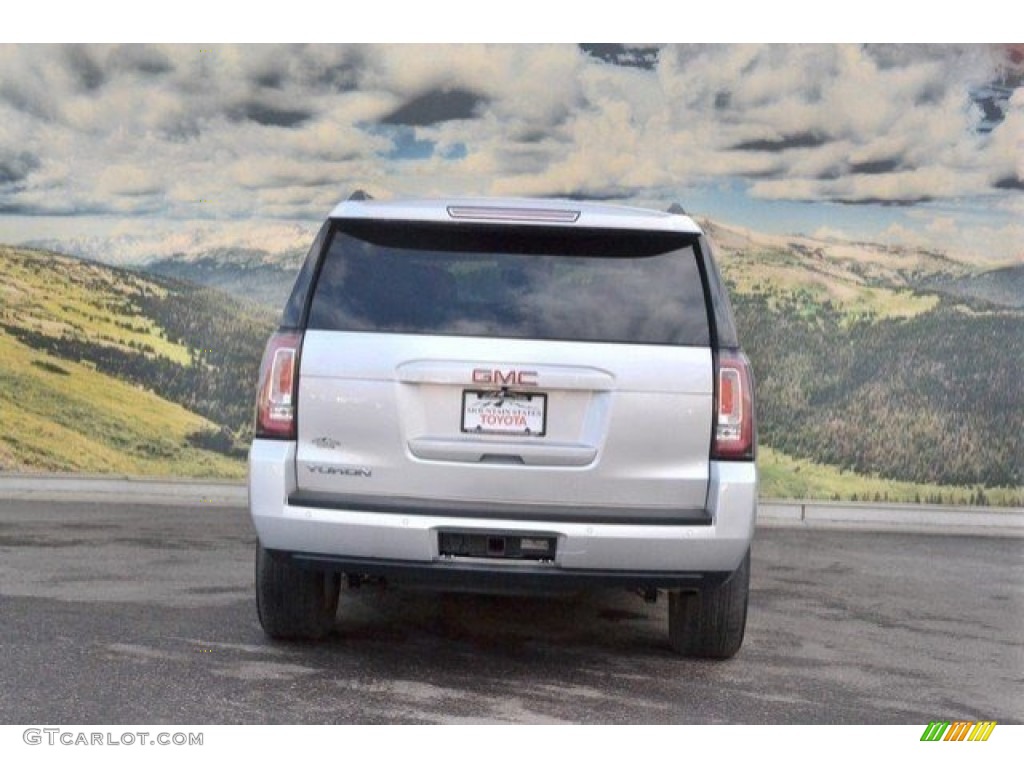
[296,220,714,521]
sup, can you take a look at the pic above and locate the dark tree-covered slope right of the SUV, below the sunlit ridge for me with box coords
[733,294,1024,487]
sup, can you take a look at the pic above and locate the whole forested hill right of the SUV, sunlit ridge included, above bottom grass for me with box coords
[718,229,1024,487]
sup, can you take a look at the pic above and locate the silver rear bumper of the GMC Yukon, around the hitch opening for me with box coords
[249,439,757,590]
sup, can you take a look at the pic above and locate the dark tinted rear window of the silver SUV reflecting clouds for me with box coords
[307,221,709,346]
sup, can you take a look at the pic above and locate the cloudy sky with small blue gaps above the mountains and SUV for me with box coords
[0,43,1024,263]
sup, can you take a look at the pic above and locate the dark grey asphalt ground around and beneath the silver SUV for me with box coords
[0,499,1024,727]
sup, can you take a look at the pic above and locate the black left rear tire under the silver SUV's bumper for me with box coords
[256,544,341,640]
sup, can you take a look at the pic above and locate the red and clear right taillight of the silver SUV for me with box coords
[711,350,754,459]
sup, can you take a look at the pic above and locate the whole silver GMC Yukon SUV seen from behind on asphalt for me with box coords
[249,194,758,657]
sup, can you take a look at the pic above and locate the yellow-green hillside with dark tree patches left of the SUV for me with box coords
[0,246,273,477]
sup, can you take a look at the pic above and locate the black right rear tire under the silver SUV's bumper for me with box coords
[669,550,751,658]
